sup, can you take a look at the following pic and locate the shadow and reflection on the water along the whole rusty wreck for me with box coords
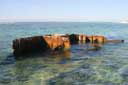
[0,44,105,65]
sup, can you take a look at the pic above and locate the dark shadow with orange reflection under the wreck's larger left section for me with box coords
[0,47,71,65]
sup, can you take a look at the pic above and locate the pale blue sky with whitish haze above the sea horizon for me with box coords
[0,0,128,21]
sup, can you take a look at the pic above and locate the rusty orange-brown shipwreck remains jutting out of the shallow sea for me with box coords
[13,34,123,55]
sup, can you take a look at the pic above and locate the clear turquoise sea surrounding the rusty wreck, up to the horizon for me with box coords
[0,22,128,85]
